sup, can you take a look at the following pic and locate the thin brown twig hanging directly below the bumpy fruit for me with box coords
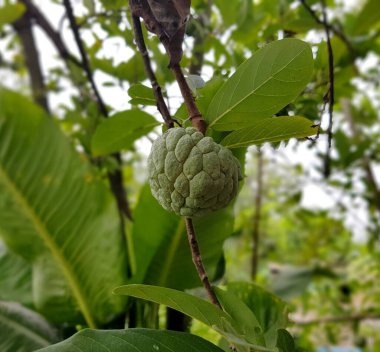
[185,218,222,309]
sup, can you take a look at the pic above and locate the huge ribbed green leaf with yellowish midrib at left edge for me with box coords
[0,90,126,326]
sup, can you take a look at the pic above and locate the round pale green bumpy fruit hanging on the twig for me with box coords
[148,127,242,217]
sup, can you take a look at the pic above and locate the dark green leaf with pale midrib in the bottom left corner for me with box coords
[0,301,58,352]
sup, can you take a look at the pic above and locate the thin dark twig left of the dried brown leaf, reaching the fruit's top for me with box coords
[132,15,174,128]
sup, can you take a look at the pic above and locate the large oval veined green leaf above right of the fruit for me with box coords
[206,39,313,131]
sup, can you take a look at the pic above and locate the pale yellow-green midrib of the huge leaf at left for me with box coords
[0,166,96,329]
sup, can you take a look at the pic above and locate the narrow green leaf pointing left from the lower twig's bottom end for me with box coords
[114,285,232,328]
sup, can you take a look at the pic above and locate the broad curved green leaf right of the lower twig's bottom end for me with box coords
[227,282,288,347]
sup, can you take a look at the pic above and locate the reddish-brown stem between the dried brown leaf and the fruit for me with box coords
[171,65,207,134]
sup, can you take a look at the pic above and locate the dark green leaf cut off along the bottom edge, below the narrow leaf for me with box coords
[39,329,223,352]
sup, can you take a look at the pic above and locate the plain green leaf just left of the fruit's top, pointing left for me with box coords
[91,109,159,156]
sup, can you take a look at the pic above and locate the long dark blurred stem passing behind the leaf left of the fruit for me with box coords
[63,0,132,221]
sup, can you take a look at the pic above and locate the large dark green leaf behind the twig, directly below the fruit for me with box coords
[132,185,233,289]
